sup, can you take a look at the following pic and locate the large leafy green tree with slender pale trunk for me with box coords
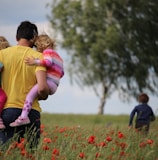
[49,0,158,114]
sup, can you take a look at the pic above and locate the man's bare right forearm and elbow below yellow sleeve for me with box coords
[36,70,49,100]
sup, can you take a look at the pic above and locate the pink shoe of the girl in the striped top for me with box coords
[10,116,30,127]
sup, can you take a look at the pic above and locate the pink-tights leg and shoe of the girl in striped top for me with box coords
[10,84,38,127]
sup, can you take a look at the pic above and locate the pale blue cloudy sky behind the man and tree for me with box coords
[0,0,158,115]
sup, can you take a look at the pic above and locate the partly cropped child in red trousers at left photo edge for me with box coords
[0,36,10,129]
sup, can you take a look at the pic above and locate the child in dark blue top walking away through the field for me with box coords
[129,93,155,134]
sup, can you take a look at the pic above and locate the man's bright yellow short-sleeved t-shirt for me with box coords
[0,46,46,112]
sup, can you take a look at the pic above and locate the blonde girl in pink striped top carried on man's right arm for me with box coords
[10,35,64,127]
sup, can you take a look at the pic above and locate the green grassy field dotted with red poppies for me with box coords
[0,113,158,160]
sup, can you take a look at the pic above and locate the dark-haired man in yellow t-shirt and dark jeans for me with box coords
[0,21,49,146]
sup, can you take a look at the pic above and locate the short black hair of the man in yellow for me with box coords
[16,21,38,41]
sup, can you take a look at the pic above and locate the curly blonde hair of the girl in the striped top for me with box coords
[34,34,56,52]
